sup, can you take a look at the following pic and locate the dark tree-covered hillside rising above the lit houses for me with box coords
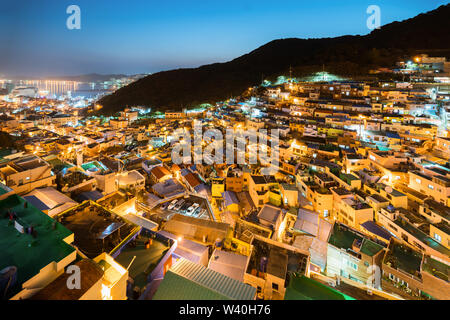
[99,5,450,114]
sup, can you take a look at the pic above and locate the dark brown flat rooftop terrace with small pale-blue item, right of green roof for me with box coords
[57,201,139,259]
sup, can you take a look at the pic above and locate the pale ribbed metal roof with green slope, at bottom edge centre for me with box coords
[153,259,256,300]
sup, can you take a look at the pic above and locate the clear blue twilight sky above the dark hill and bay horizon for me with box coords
[0,0,448,76]
